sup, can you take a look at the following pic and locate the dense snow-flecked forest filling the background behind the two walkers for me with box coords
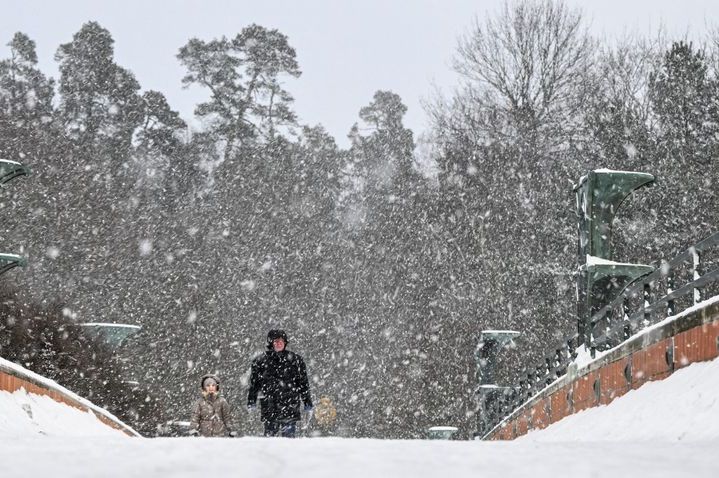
[0,1,719,438]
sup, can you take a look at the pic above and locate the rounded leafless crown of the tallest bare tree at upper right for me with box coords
[454,0,594,152]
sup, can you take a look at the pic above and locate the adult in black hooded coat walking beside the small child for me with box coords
[247,330,313,438]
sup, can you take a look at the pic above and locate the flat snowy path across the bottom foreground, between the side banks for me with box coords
[0,437,719,478]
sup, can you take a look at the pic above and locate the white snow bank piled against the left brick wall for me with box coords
[0,389,127,438]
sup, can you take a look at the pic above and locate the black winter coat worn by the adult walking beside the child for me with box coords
[247,350,312,422]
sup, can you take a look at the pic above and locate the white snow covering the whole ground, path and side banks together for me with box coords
[0,360,719,478]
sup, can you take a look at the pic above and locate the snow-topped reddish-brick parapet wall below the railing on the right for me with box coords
[481,295,719,440]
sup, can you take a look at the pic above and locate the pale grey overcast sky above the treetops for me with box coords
[0,0,719,146]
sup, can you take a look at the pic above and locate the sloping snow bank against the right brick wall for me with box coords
[517,359,719,442]
